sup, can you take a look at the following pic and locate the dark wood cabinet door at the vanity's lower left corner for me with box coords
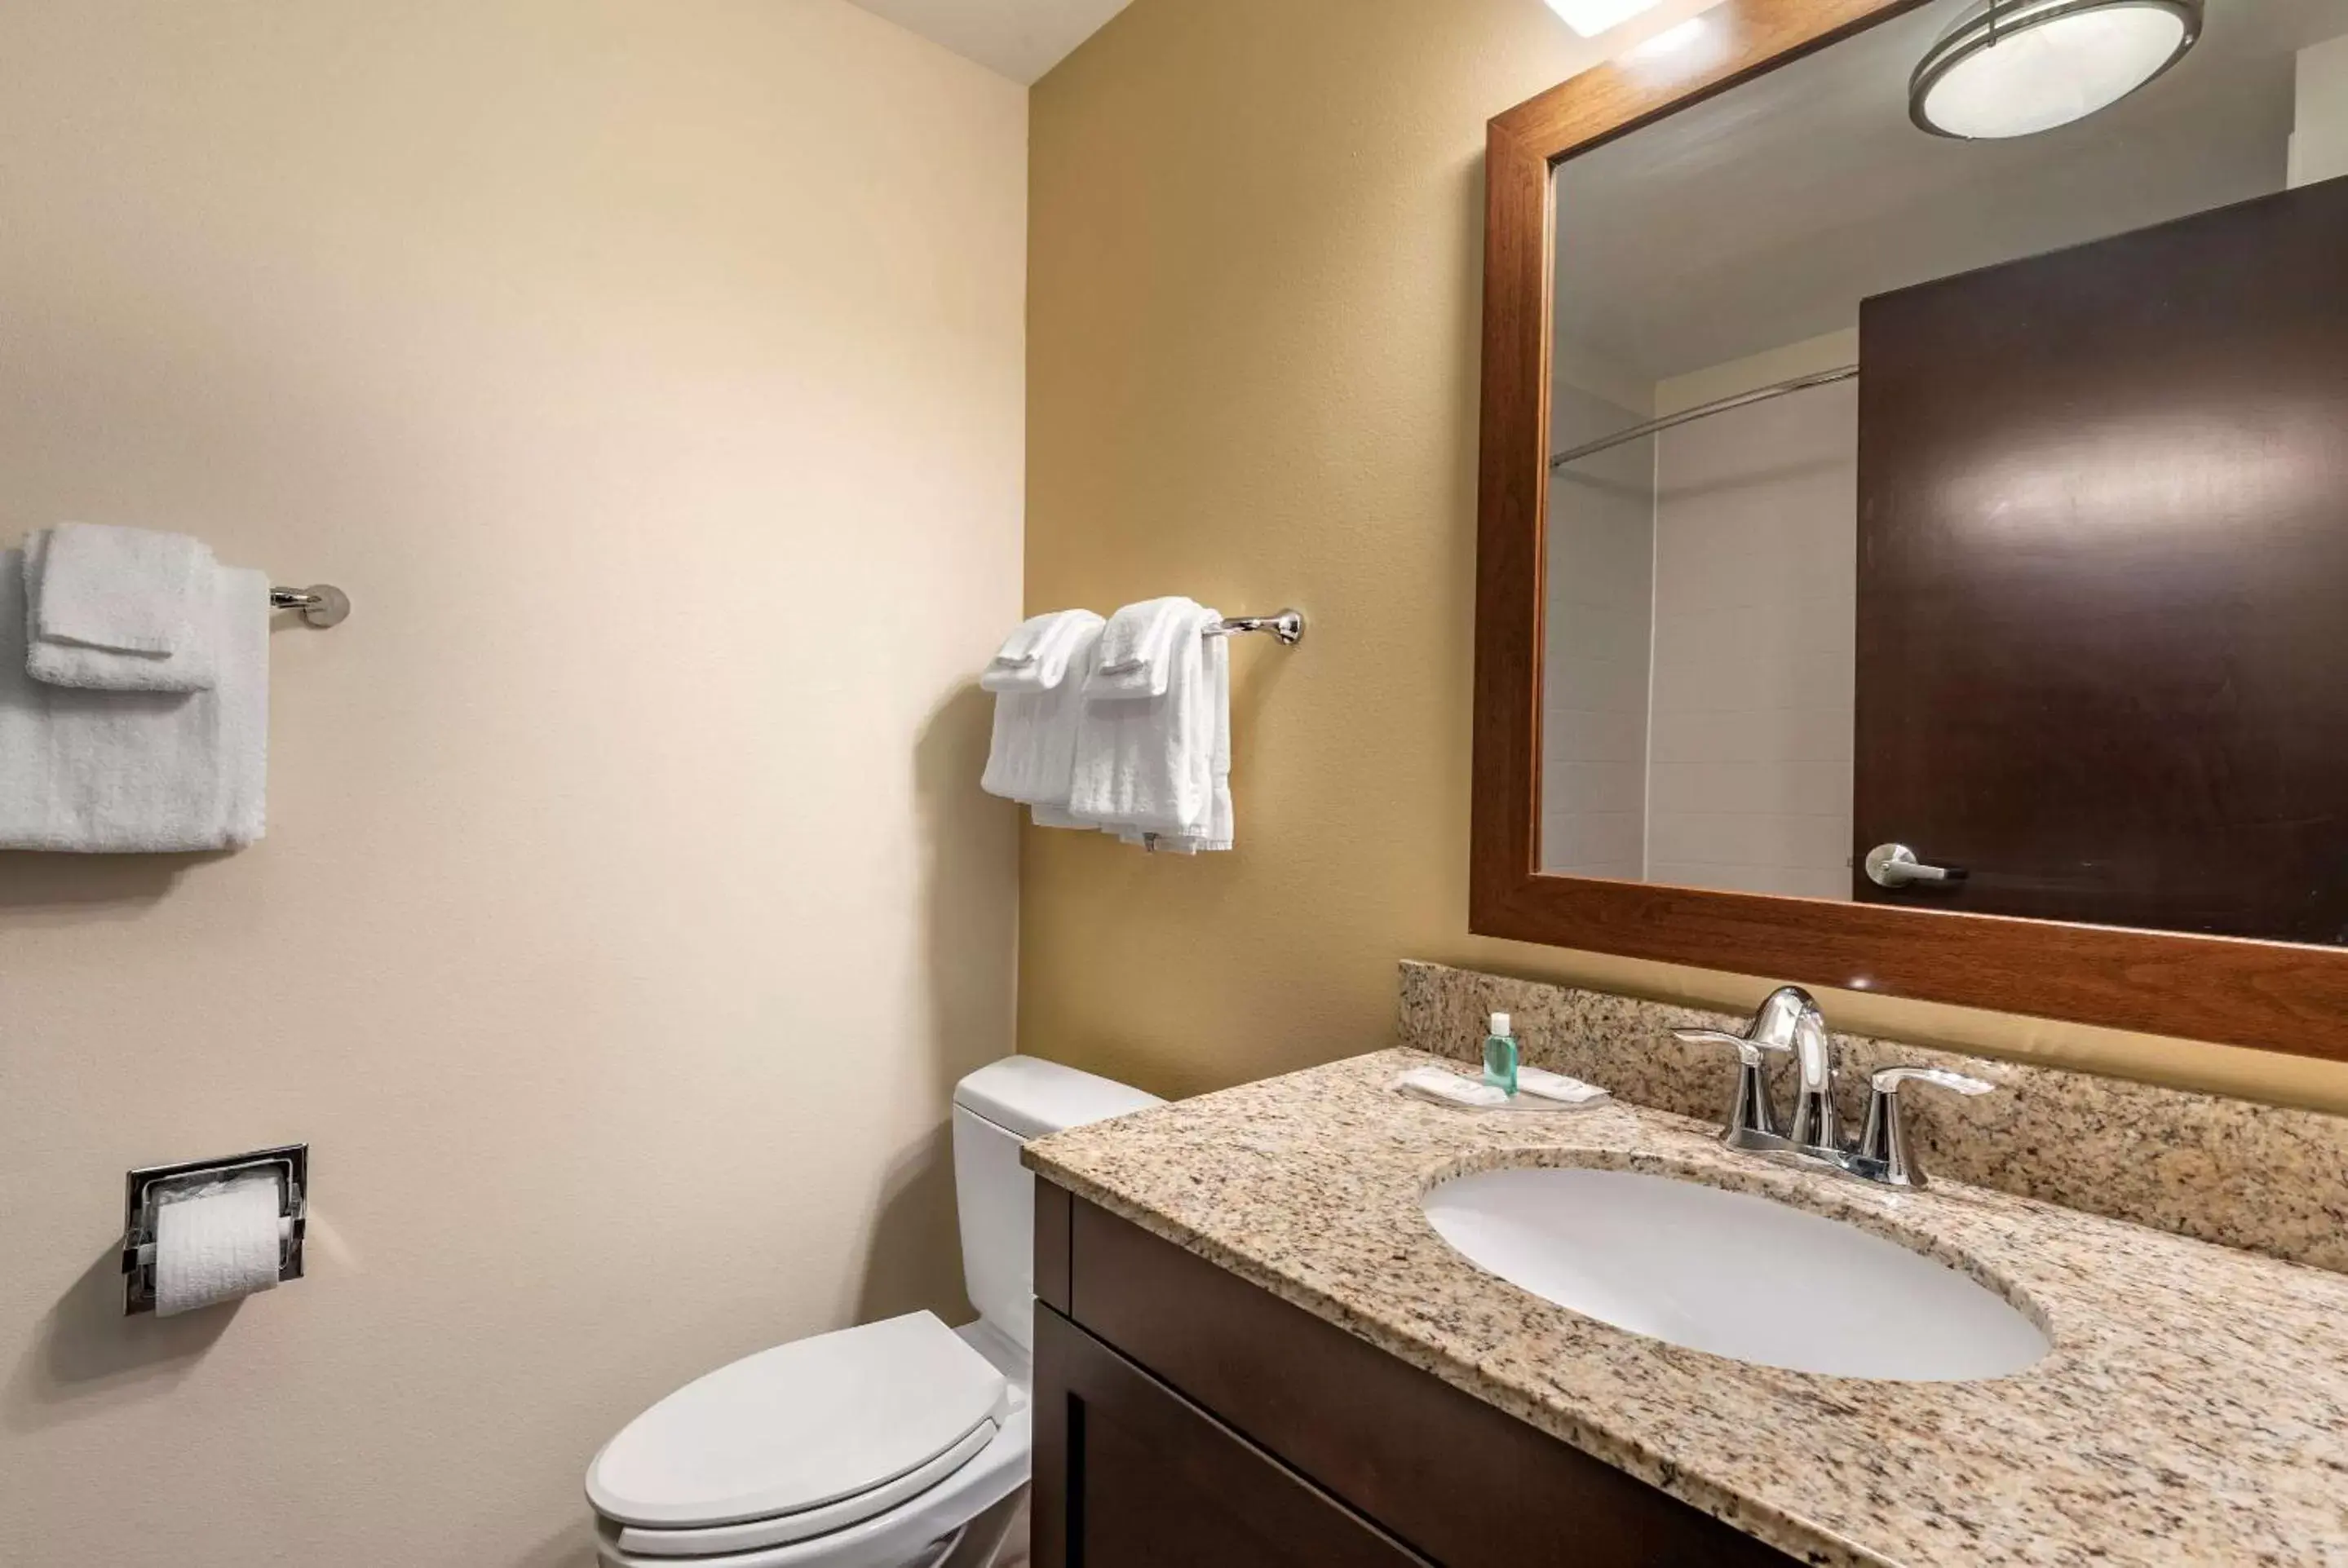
[1033,1305,1427,1568]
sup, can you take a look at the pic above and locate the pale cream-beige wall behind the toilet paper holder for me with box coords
[0,0,1026,1568]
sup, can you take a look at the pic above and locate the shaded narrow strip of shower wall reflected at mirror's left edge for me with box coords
[1541,385,1656,878]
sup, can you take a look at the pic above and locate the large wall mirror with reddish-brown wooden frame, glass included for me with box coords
[1470,0,2348,1058]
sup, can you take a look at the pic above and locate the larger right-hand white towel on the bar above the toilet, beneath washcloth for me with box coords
[1068,603,1231,847]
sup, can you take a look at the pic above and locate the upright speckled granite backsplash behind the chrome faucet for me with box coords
[1397,962,2348,1272]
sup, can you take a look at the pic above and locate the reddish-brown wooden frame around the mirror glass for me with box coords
[1467,0,2348,1061]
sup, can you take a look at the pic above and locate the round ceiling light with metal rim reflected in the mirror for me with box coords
[1909,0,2203,141]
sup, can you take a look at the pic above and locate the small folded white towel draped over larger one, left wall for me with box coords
[24,523,218,692]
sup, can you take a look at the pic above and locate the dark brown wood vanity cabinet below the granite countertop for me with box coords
[1033,1181,1792,1568]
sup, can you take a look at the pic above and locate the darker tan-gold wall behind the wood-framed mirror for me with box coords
[1019,0,2348,1108]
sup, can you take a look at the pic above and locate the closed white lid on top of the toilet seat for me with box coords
[587,1312,1010,1528]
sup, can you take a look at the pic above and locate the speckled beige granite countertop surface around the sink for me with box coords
[1026,1049,2348,1568]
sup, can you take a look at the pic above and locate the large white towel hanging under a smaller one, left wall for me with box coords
[0,550,270,855]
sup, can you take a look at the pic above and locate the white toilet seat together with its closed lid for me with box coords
[587,1312,1033,1568]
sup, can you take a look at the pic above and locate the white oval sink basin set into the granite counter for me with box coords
[1423,1169,2047,1383]
